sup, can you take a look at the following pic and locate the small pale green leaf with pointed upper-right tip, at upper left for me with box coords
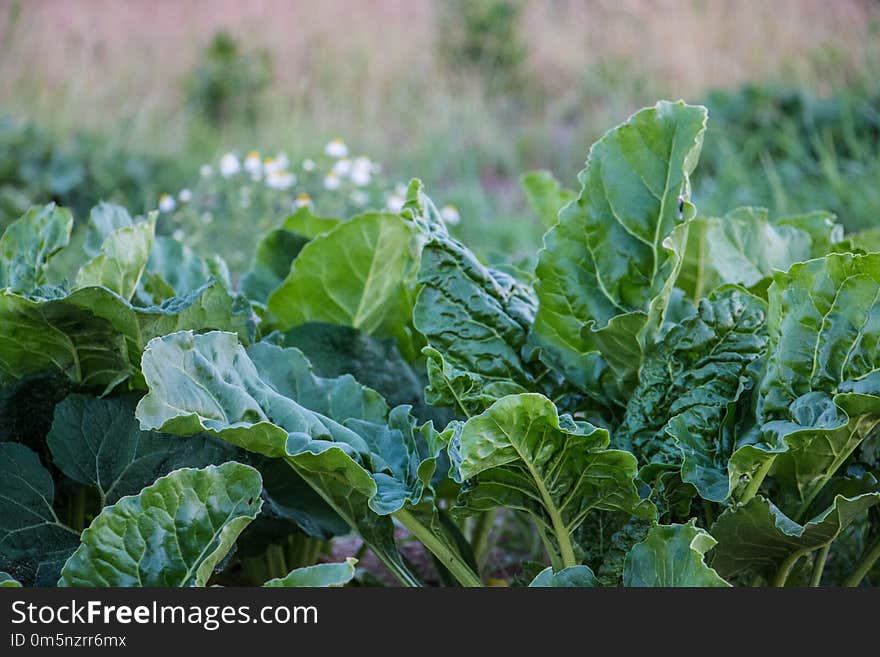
[76,212,157,301]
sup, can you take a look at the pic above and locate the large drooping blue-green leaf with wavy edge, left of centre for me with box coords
[137,332,441,581]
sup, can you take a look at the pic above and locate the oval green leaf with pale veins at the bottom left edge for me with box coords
[58,461,263,587]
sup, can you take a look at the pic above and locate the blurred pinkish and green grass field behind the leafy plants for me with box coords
[0,0,880,260]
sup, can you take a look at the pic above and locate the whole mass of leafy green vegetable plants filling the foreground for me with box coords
[0,102,880,587]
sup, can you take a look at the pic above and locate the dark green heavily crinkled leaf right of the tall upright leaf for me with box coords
[614,286,772,502]
